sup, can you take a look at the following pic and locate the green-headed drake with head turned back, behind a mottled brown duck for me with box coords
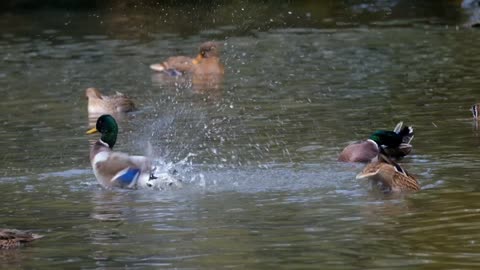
[338,122,413,163]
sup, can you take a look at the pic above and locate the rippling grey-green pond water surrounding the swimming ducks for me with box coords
[0,1,480,269]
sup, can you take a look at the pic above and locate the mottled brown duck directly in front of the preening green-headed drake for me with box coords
[356,153,420,193]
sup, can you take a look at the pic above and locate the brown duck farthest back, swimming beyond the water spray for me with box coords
[150,41,225,76]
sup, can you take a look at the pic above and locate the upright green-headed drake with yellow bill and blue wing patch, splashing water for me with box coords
[87,114,156,189]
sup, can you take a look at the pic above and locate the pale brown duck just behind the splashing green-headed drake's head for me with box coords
[85,87,135,115]
